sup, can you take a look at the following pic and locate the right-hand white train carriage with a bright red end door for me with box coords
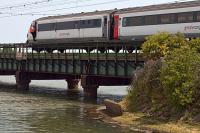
[114,1,200,40]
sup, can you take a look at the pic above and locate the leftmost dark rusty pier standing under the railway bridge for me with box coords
[15,71,31,91]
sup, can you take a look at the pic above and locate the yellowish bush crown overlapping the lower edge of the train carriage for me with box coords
[142,32,186,59]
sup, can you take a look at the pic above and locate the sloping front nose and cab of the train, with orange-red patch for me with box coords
[27,21,37,43]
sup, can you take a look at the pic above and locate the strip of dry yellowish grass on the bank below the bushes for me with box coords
[112,112,200,133]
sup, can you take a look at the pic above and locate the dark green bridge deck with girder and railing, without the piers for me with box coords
[0,45,144,77]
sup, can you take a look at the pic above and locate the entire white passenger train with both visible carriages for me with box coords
[27,1,200,51]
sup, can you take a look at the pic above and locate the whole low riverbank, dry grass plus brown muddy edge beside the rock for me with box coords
[97,106,200,133]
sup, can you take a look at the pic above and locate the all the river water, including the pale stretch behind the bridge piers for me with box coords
[0,76,136,133]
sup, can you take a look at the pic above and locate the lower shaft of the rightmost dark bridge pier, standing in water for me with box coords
[83,85,99,99]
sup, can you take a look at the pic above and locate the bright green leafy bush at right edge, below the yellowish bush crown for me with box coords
[161,47,200,107]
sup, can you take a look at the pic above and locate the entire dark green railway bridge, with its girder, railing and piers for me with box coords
[0,43,144,98]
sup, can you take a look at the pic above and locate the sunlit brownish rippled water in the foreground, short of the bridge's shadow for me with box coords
[0,88,134,133]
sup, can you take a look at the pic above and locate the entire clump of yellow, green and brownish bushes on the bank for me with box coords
[126,32,200,115]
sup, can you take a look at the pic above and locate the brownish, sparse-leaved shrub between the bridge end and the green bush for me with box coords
[126,60,162,111]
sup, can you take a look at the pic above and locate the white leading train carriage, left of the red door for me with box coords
[28,11,113,43]
